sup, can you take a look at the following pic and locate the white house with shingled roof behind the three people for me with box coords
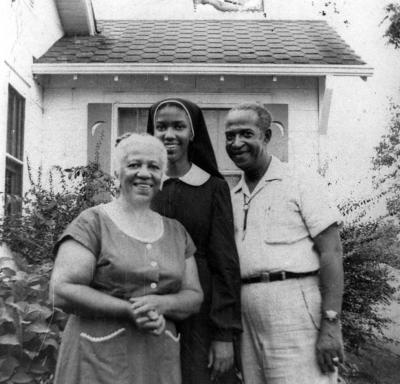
[0,0,372,216]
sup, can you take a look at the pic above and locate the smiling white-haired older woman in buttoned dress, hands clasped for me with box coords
[50,134,202,384]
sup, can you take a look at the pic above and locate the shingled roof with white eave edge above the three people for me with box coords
[32,20,373,77]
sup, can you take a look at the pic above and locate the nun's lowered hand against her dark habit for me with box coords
[208,341,233,381]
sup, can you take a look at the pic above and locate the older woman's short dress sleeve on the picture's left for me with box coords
[53,208,101,258]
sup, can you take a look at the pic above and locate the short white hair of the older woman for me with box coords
[114,132,167,174]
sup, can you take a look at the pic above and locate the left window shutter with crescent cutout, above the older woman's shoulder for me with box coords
[87,103,112,173]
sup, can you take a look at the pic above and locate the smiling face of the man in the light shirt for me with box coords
[225,110,269,172]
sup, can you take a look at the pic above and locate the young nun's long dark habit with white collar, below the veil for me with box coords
[152,164,241,384]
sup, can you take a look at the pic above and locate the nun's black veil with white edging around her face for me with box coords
[147,99,223,179]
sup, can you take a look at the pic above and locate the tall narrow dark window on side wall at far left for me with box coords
[4,86,25,214]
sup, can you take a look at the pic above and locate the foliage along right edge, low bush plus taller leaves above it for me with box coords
[342,104,400,348]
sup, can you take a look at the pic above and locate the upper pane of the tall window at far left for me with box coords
[7,86,25,160]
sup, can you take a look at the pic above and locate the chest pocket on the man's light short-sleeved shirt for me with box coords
[263,202,308,244]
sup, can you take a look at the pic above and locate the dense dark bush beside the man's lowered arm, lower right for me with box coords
[341,201,400,352]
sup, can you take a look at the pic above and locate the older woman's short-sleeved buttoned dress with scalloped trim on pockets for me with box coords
[55,206,195,384]
